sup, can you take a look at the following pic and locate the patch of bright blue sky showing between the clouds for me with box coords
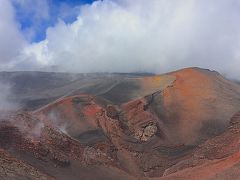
[13,0,94,42]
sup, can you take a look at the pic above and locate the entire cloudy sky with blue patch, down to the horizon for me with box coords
[0,0,240,79]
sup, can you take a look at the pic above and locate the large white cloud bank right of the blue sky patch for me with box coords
[2,0,240,77]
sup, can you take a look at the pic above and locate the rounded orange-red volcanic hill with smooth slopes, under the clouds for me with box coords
[151,68,240,144]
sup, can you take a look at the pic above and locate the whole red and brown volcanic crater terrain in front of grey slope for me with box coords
[1,68,240,179]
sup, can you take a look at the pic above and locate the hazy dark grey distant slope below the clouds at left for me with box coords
[0,72,151,110]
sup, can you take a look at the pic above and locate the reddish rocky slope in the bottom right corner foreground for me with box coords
[160,112,240,180]
